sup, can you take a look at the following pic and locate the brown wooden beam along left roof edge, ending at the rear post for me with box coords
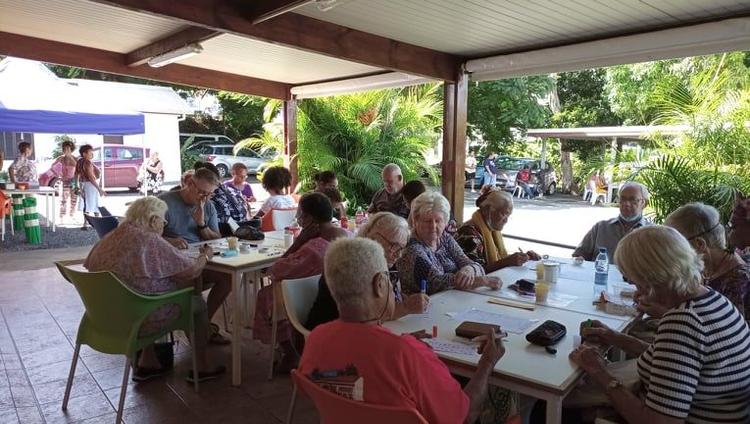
[0,32,291,100]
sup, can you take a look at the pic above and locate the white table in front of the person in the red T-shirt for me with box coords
[384,290,628,423]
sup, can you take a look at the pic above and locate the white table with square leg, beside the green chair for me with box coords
[191,231,285,386]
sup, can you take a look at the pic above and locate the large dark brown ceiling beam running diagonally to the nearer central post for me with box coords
[88,0,464,82]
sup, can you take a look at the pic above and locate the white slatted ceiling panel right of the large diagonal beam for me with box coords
[296,0,750,57]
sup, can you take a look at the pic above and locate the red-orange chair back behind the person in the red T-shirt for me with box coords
[292,370,427,424]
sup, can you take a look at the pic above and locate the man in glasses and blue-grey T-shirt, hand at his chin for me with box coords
[159,168,221,249]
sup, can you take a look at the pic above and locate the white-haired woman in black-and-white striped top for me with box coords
[570,225,750,424]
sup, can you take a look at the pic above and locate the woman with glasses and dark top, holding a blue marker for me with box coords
[305,212,429,330]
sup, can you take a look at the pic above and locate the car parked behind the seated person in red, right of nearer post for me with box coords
[475,156,557,194]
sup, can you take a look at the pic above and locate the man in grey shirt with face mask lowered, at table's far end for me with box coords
[573,182,649,262]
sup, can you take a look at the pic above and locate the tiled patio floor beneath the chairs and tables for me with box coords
[0,266,318,424]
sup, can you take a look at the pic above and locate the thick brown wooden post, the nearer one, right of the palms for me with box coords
[442,72,469,225]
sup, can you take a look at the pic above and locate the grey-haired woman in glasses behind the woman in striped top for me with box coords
[668,203,750,319]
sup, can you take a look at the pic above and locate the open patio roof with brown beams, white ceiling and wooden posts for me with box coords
[0,0,750,220]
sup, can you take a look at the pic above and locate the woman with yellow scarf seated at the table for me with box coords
[454,190,541,273]
